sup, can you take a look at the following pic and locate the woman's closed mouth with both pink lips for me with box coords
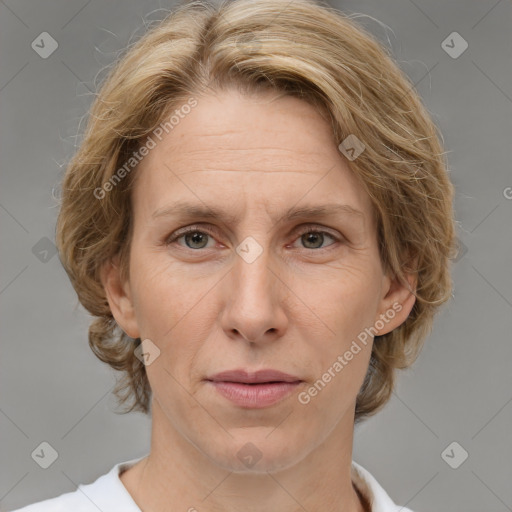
[206,369,303,409]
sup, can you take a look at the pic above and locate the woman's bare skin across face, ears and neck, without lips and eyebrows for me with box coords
[102,90,415,512]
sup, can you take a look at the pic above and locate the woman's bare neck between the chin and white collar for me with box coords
[120,400,369,512]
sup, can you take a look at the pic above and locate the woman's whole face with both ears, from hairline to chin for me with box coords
[104,86,413,471]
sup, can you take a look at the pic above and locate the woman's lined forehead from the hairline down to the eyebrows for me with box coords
[134,90,371,226]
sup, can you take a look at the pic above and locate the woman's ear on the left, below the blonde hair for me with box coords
[100,256,140,338]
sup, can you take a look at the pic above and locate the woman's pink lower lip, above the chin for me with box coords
[209,381,301,409]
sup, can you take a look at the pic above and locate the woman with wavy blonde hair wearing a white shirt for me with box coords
[12,0,454,512]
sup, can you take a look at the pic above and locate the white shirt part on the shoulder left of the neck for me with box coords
[11,457,143,512]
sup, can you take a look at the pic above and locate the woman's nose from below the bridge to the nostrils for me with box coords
[221,247,290,343]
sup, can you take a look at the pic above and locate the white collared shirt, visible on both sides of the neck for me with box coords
[12,457,412,512]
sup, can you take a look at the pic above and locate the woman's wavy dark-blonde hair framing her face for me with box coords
[56,0,455,422]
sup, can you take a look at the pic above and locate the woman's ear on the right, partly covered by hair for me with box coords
[374,266,417,336]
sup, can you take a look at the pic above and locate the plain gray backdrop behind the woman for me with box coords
[0,0,512,512]
